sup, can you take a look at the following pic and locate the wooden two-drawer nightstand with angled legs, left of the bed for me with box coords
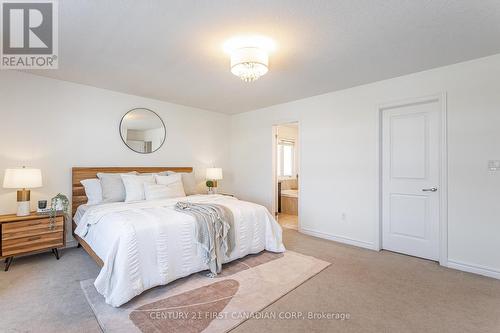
[0,213,66,271]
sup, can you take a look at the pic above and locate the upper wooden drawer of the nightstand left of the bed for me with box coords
[2,216,64,241]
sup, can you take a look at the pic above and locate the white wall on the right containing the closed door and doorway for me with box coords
[231,55,500,278]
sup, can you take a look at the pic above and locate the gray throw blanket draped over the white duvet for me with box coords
[175,202,235,277]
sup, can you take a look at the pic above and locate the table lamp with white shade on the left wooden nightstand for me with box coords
[3,167,42,216]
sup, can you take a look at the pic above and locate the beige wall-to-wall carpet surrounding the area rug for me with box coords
[0,229,500,333]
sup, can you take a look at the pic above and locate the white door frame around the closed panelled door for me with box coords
[374,92,448,266]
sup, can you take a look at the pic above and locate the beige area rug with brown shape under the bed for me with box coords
[80,251,330,333]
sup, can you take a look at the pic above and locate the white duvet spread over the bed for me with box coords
[75,195,285,306]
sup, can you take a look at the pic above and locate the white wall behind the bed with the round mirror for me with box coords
[0,71,231,241]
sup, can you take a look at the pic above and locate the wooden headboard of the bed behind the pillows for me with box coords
[71,167,193,215]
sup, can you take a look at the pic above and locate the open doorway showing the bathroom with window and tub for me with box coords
[273,122,300,230]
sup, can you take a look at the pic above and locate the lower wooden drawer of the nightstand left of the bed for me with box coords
[2,231,64,256]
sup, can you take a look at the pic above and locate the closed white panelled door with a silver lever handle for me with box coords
[382,99,441,260]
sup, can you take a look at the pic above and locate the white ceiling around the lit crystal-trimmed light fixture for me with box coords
[28,0,500,114]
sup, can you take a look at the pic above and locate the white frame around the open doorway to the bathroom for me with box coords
[271,120,302,228]
